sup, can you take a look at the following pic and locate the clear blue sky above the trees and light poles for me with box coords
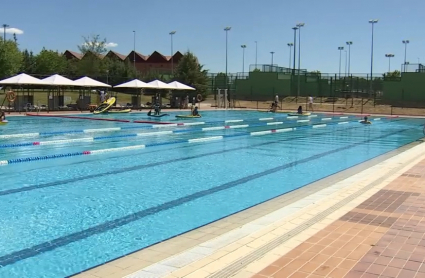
[1,0,425,74]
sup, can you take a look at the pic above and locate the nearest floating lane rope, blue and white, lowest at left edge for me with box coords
[0,116,392,166]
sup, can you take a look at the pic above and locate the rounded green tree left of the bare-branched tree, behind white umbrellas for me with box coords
[34,48,68,75]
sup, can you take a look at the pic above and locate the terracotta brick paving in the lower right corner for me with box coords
[253,160,425,278]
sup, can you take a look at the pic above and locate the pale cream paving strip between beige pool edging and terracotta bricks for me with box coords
[125,141,424,278]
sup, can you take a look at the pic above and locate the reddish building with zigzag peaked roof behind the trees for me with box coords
[63,50,183,73]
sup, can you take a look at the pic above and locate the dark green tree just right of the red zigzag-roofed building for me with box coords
[175,51,209,99]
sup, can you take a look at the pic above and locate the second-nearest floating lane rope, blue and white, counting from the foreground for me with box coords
[0,116,364,149]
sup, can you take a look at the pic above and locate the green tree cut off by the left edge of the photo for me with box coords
[0,38,22,78]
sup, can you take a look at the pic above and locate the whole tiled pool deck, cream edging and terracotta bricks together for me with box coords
[75,142,425,278]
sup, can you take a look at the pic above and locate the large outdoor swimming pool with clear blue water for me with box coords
[0,111,423,277]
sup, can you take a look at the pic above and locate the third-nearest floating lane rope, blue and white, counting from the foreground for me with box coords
[0,115,362,141]
